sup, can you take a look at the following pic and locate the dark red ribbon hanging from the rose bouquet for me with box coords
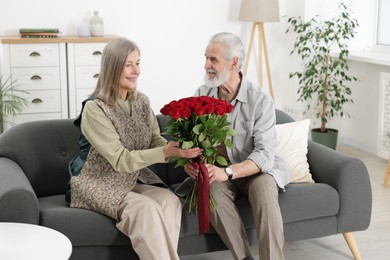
[193,157,210,235]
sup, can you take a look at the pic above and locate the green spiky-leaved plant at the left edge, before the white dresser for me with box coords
[0,76,28,134]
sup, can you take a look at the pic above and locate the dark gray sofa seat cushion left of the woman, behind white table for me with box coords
[39,195,130,246]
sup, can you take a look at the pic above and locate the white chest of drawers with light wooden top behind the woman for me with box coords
[0,35,118,129]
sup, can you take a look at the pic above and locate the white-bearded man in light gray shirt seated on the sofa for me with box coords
[184,33,289,260]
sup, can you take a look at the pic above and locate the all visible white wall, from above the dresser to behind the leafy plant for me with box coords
[0,0,388,157]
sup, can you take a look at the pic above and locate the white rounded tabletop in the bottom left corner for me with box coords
[0,222,72,260]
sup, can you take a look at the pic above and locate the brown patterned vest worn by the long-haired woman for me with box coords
[71,93,162,220]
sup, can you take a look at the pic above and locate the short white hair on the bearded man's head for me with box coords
[209,32,245,71]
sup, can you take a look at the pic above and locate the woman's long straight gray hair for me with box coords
[91,38,140,105]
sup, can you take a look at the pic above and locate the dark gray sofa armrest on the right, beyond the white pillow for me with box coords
[308,141,372,233]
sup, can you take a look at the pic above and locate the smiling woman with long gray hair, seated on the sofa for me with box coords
[67,38,202,260]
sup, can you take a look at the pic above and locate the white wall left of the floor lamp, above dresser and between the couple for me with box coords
[0,0,249,111]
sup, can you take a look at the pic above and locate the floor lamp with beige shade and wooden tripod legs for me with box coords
[239,0,280,98]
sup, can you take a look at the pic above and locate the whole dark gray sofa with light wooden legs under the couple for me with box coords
[0,110,372,260]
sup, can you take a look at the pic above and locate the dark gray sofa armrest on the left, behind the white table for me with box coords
[0,157,39,224]
